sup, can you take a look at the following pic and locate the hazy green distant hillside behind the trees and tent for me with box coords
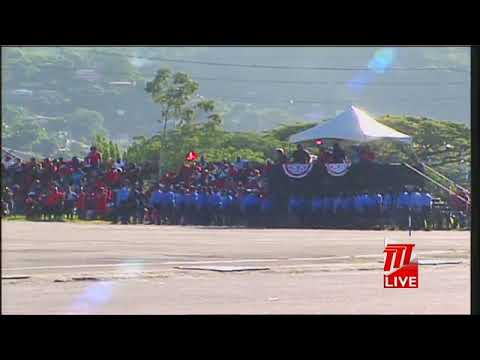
[2,47,470,158]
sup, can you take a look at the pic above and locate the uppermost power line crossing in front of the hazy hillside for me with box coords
[92,50,469,73]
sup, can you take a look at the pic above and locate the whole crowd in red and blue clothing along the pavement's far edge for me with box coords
[2,144,468,228]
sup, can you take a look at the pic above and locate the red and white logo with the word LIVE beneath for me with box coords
[383,244,418,288]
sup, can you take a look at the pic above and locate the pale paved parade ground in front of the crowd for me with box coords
[2,221,470,314]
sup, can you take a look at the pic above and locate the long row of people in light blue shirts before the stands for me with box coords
[115,187,435,229]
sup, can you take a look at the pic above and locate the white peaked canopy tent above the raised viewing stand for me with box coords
[289,106,412,143]
